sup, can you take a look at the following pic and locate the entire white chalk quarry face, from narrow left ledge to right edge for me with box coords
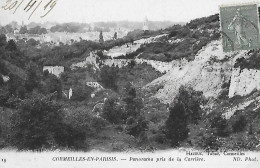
[72,41,260,103]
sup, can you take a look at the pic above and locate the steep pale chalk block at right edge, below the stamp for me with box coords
[228,68,260,98]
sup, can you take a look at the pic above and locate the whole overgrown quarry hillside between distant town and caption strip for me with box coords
[0,12,260,152]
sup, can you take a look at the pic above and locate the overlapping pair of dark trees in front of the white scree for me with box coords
[166,86,204,146]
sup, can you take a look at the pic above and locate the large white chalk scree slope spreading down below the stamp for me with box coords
[147,41,246,103]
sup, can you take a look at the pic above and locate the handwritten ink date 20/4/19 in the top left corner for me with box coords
[2,0,57,20]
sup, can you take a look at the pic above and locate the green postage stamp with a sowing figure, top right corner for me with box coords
[220,4,260,52]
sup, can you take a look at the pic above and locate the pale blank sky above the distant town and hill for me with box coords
[0,0,260,25]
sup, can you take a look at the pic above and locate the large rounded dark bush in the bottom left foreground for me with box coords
[11,95,80,150]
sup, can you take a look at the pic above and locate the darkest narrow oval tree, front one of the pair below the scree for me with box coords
[166,103,189,147]
